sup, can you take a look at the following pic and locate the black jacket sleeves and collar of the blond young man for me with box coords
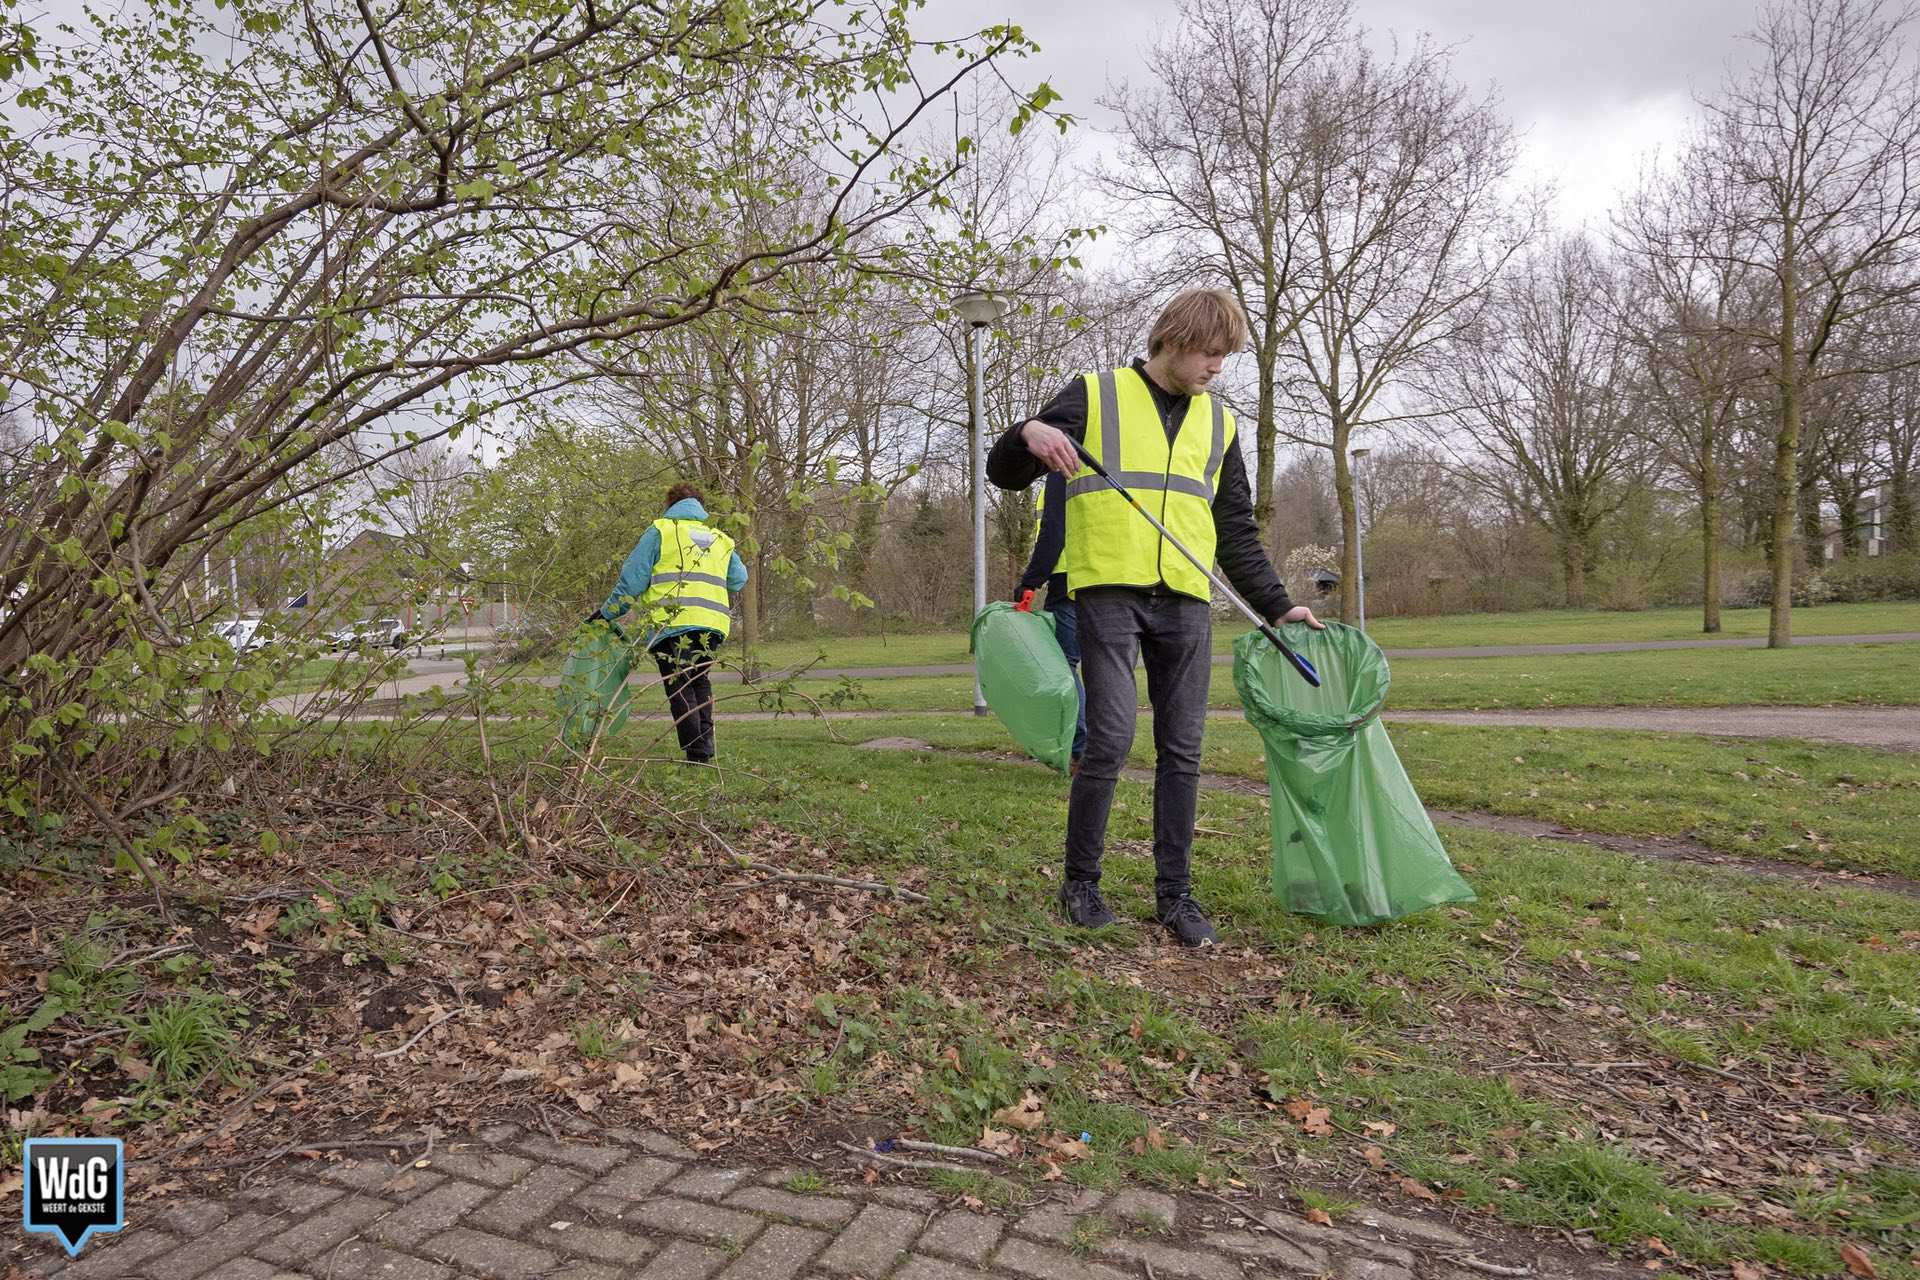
[987,359,1292,622]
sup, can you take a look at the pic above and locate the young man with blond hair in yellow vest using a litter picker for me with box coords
[987,290,1321,946]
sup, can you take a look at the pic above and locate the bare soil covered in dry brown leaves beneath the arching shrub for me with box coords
[0,791,952,1171]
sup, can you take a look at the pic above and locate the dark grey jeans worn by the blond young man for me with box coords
[1066,587,1213,898]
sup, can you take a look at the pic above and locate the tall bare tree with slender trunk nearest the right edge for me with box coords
[1686,0,1920,649]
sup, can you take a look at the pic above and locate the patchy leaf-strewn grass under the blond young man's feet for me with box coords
[648,722,1920,1276]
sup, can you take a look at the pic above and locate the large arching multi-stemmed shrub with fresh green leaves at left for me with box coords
[0,0,1050,818]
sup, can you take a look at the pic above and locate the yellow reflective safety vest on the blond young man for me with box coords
[1064,368,1235,601]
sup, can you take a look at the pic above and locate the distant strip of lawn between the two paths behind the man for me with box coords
[721,643,1920,712]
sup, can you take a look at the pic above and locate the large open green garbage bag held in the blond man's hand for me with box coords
[1233,622,1473,925]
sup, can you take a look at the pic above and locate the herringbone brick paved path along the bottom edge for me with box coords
[15,1125,1574,1280]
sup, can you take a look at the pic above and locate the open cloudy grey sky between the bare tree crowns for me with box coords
[914,0,1757,226]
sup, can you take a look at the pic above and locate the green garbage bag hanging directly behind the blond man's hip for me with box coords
[968,601,1079,773]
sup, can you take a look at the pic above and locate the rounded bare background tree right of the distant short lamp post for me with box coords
[1427,236,1644,606]
